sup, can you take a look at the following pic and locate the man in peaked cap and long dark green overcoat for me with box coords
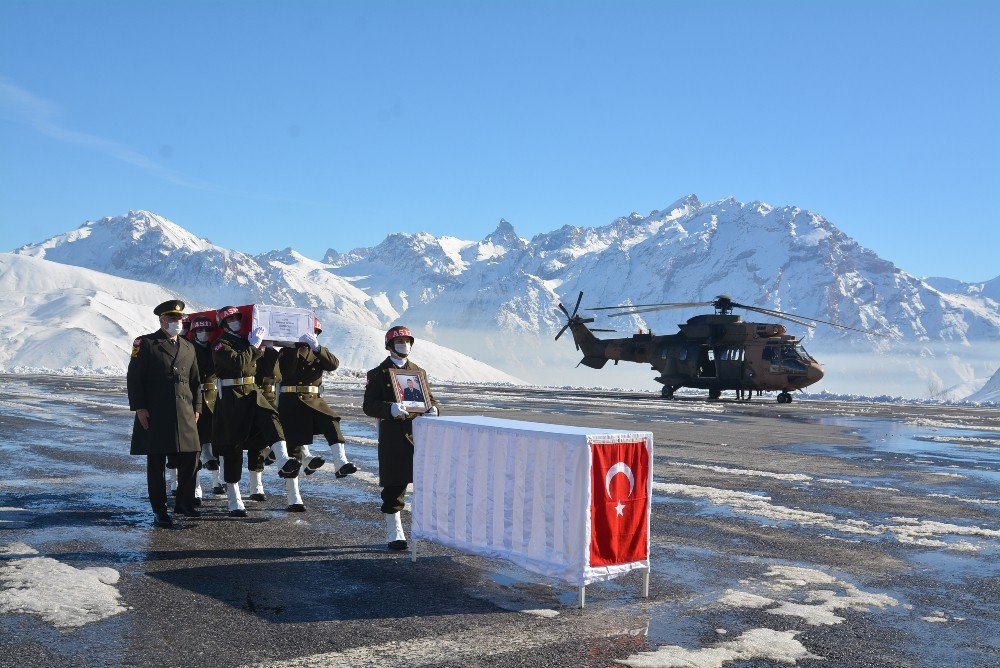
[126,300,201,528]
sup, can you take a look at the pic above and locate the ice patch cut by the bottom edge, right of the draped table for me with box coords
[616,629,823,668]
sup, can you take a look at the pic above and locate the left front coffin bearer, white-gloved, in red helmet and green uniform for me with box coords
[212,306,300,517]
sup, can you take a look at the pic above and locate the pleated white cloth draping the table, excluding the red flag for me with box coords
[412,416,652,586]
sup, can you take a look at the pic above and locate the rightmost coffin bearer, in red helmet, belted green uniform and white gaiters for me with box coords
[278,320,358,512]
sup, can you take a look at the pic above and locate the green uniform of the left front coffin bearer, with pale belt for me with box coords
[212,332,285,483]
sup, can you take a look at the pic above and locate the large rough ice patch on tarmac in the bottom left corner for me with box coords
[0,543,127,628]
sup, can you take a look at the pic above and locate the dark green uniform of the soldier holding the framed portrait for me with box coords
[362,357,440,513]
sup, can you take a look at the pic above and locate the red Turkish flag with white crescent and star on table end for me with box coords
[590,441,650,566]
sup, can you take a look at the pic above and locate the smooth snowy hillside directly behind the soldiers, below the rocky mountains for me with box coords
[0,253,518,382]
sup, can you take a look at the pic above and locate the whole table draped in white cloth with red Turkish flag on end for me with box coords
[411,416,653,607]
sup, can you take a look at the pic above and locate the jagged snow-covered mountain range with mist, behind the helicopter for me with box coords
[9,195,1000,397]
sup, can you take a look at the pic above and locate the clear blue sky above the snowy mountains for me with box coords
[0,0,1000,281]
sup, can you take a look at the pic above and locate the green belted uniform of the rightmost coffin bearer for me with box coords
[278,345,345,448]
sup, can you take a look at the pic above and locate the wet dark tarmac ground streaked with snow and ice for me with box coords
[0,376,1000,668]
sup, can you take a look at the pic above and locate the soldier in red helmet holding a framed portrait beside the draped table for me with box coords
[362,327,439,550]
